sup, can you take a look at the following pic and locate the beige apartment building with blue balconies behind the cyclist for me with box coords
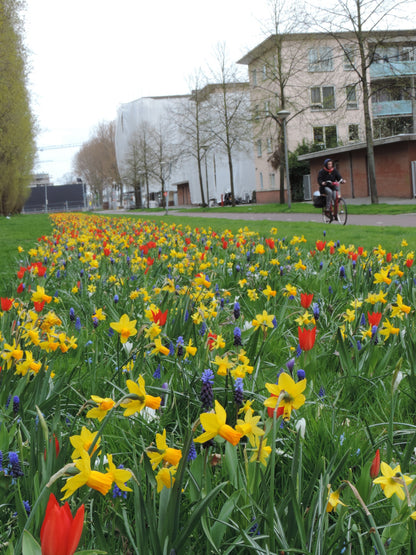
[238,30,416,202]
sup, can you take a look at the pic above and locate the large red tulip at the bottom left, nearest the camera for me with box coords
[40,493,85,555]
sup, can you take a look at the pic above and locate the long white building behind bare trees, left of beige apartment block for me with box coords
[115,83,255,206]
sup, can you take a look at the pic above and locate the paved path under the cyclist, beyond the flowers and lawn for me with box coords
[109,211,416,227]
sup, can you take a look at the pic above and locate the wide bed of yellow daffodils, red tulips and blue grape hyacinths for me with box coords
[0,214,416,554]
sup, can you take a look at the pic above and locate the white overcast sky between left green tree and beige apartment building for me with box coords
[25,0,270,183]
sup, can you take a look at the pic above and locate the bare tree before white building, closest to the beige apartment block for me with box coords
[204,44,251,206]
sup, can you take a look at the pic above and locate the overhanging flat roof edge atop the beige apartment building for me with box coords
[237,29,416,65]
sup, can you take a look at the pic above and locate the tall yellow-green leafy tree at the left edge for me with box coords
[0,0,35,215]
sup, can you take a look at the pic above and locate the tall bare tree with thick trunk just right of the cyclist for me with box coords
[313,0,410,204]
